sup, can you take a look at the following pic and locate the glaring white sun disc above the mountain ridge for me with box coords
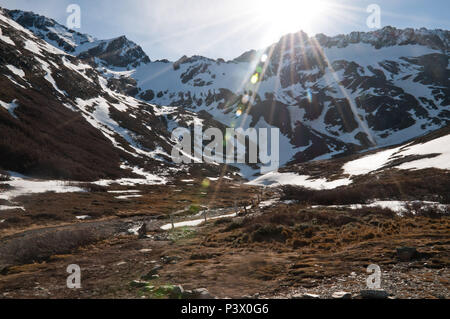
[256,0,329,40]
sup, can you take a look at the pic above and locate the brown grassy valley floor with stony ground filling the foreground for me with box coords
[0,176,450,298]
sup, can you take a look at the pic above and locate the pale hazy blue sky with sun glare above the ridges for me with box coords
[0,0,450,60]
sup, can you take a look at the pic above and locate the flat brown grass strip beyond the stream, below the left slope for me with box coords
[0,179,260,238]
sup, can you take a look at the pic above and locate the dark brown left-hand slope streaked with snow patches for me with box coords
[0,9,223,182]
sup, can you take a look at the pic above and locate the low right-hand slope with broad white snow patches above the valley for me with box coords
[249,126,450,190]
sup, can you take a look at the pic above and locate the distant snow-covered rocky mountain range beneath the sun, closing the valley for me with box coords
[1,7,450,181]
